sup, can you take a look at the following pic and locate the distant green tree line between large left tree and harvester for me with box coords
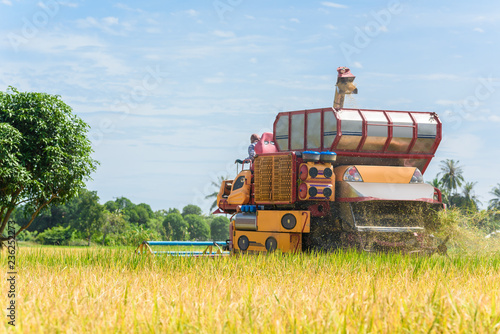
[11,189,229,245]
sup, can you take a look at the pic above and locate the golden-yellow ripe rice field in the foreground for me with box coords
[0,247,500,333]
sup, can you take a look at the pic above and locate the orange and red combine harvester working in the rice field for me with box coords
[217,67,445,253]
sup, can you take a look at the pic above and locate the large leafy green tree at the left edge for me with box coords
[0,87,97,241]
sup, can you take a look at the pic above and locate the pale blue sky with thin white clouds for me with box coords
[0,0,500,211]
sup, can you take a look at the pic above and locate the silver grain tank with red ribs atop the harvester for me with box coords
[274,108,442,172]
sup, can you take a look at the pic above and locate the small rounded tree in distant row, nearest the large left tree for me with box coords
[71,189,105,246]
